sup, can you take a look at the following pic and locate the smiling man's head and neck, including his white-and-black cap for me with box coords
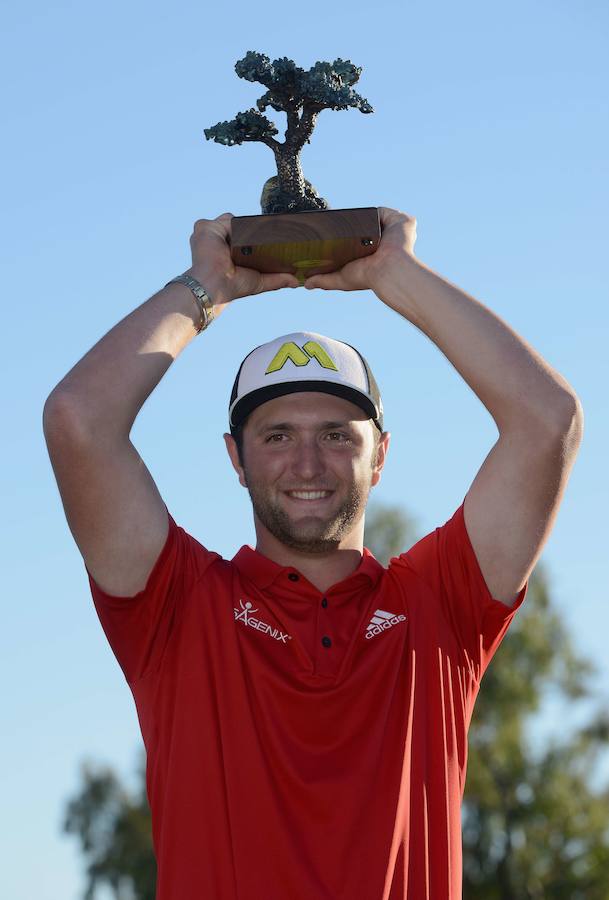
[225,332,389,591]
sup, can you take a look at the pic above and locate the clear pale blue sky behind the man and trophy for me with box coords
[0,0,609,900]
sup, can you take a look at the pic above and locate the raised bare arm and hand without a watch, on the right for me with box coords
[305,207,584,606]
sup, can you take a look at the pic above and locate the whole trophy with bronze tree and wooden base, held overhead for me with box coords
[204,50,381,284]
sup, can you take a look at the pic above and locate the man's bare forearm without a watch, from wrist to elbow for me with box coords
[375,256,576,432]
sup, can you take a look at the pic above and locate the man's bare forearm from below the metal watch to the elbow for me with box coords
[45,270,200,438]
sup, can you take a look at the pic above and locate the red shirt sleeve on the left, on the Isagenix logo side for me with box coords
[85,511,220,684]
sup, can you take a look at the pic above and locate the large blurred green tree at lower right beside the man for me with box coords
[462,565,609,900]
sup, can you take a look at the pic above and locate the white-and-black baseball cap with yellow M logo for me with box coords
[228,331,383,432]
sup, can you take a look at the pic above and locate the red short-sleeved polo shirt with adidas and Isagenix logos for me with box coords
[89,504,528,900]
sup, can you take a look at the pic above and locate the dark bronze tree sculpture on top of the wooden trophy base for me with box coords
[204,50,374,215]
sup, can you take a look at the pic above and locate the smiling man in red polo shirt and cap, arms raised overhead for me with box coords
[44,207,583,900]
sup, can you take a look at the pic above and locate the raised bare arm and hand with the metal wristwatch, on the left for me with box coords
[43,213,298,596]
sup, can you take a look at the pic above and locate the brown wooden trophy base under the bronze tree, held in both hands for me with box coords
[231,206,381,284]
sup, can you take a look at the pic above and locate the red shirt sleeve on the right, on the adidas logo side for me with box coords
[399,501,529,678]
